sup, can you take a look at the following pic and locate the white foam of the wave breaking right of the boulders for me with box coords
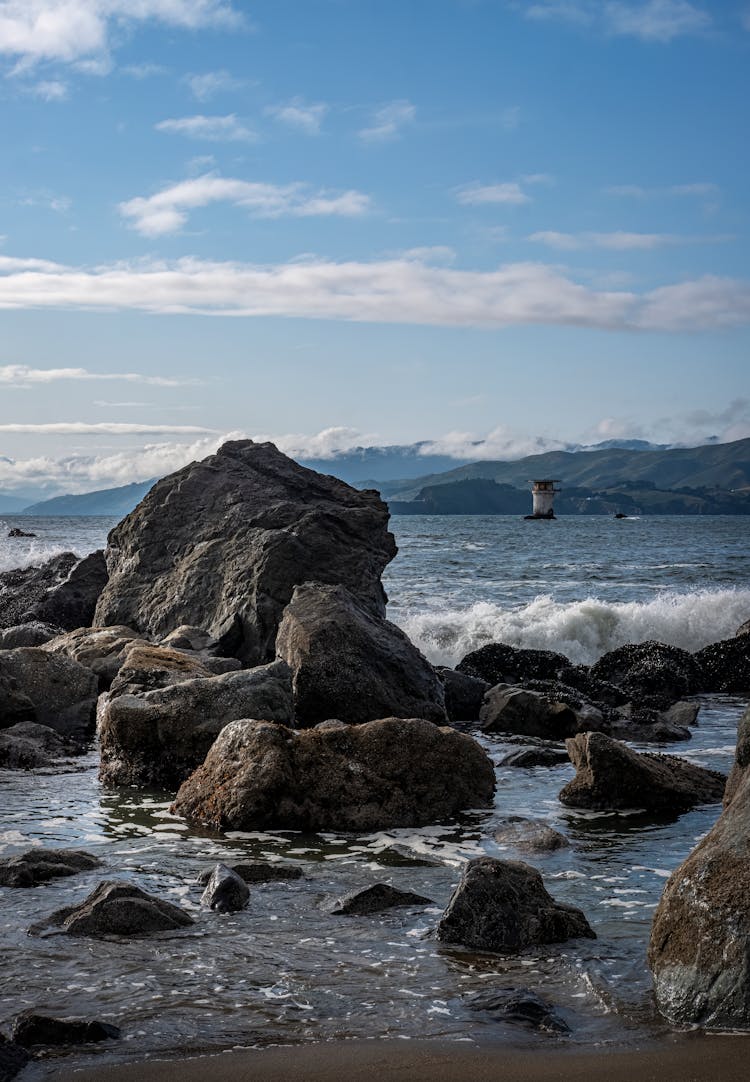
[391,589,750,665]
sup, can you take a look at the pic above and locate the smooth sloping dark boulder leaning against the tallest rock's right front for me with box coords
[276,582,446,726]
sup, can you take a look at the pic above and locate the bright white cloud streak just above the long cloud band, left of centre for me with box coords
[119,174,370,237]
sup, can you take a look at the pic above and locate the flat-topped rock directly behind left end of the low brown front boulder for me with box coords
[100,661,294,789]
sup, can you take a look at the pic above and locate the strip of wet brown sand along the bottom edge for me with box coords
[54,1034,750,1082]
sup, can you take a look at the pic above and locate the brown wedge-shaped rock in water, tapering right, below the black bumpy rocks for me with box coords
[560,733,726,815]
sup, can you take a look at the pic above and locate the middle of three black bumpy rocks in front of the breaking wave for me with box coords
[591,642,703,710]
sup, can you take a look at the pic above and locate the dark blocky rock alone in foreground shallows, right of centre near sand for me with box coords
[437,857,596,953]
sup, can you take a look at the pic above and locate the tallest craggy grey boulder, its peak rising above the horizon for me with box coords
[95,440,396,664]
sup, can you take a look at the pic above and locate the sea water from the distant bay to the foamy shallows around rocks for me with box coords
[0,516,750,1079]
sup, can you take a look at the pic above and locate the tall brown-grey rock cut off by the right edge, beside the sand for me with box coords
[648,748,750,1030]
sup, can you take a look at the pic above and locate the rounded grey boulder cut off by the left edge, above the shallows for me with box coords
[0,646,97,739]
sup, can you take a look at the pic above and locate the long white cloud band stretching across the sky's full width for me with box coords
[0,248,750,333]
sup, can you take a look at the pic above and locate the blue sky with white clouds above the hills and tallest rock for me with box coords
[0,0,750,497]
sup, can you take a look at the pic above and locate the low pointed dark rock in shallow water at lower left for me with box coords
[29,880,193,938]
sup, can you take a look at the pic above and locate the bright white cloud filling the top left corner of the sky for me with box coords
[0,0,242,70]
